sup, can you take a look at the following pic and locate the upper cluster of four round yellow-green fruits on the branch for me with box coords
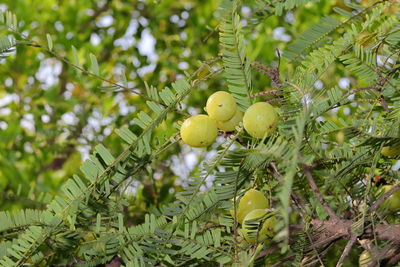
[180,91,278,147]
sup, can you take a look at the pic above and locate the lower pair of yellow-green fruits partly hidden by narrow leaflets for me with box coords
[230,189,277,244]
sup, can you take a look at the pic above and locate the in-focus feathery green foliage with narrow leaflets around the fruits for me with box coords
[0,0,400,267]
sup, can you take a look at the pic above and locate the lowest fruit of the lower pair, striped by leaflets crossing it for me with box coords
[242,209,276,244]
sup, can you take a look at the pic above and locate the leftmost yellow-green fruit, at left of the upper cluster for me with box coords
[181,115,218,147]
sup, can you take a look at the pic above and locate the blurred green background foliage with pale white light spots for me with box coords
[0,0,396,228]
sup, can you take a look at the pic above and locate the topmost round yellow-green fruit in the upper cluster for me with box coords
[206,91,237,121]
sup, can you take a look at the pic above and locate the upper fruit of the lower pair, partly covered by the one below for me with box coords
[236,189,269,224]
